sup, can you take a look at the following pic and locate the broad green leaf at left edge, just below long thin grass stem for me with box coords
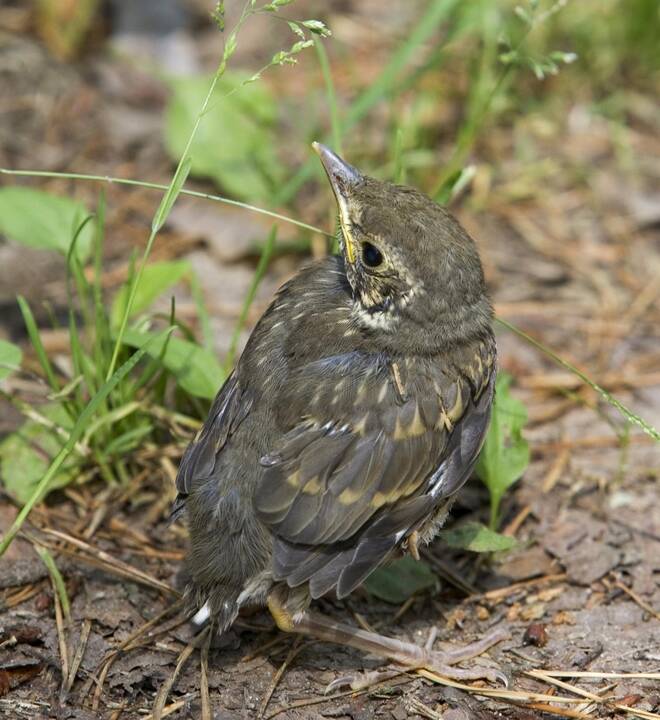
[0,187,94,260]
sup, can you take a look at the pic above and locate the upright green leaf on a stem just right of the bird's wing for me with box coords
[476,373,529,530]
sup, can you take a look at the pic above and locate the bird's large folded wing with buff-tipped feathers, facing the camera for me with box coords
[255,342,495,596]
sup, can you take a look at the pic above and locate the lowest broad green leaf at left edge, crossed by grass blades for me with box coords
[0,403,76,503]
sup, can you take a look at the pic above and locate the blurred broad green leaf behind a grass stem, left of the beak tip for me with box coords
[164,72,284,201]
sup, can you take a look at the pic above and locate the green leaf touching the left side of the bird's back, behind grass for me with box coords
[123,329,225,400]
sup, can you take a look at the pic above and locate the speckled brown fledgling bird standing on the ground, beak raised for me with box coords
[173,143,507,681]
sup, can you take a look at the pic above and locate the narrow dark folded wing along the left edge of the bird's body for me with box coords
[172,374,251,517]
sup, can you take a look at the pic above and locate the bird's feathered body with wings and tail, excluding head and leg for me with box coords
[173,258,494,622]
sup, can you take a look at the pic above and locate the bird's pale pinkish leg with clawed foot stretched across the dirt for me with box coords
[268,593,509,684]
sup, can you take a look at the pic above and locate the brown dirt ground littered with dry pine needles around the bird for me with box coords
[0,2,660,720]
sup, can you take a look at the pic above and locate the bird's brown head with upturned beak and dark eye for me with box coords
[314,143,492,346]
